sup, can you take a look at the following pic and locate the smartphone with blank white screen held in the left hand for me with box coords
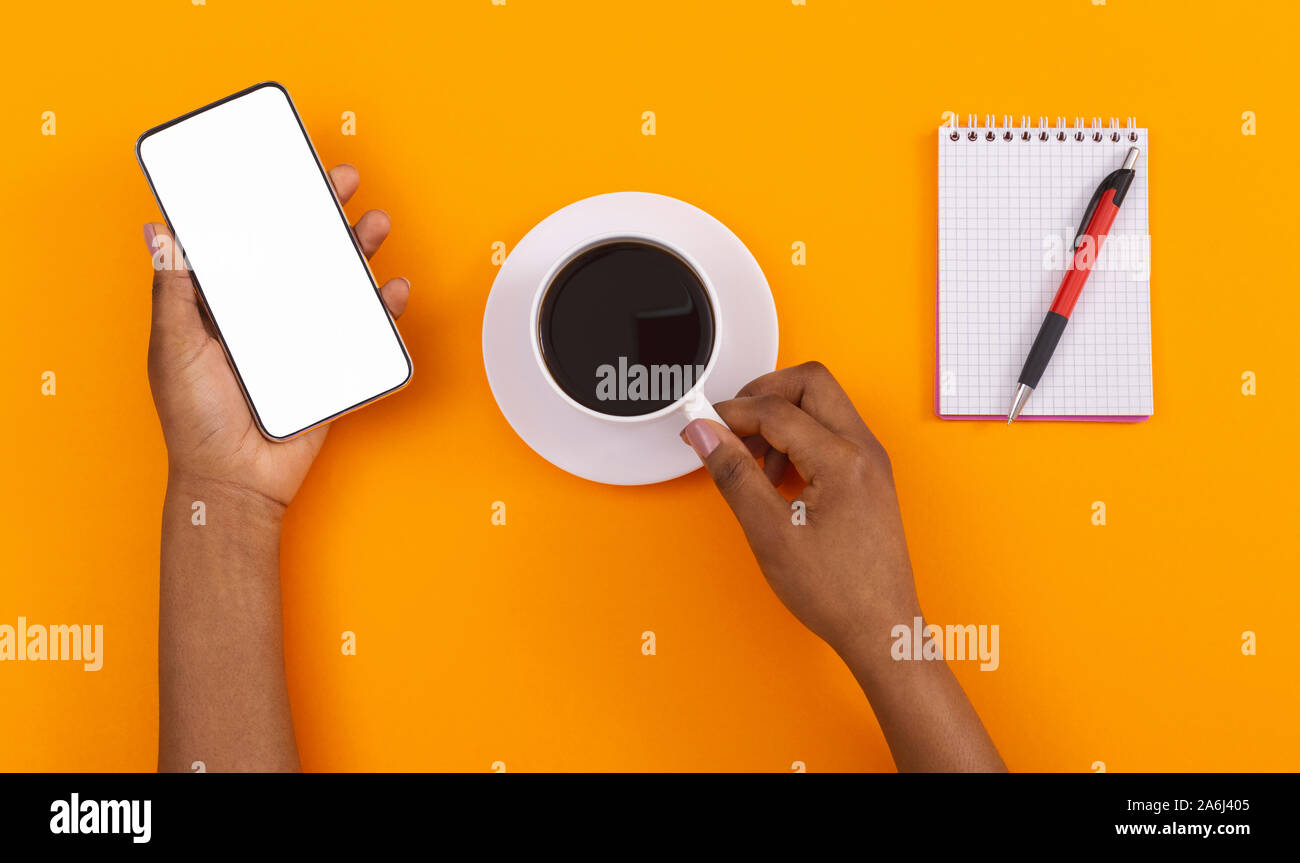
[135,82,413,441]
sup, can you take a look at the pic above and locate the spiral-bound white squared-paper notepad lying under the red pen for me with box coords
[935,117,1153,420]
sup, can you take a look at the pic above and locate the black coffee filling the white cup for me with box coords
[538,240,714,416]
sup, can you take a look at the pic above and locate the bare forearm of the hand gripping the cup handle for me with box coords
[840,608,1006,772]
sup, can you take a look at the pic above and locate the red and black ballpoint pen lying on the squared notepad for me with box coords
[1006,147,1138,425]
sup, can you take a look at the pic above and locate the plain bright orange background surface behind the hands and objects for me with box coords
[0,0,1300,771]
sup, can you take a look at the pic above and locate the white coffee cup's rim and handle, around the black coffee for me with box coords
[529,231,725,428]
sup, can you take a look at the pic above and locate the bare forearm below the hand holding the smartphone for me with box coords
[159,474,299,771]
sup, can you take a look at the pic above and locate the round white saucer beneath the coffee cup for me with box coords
[484,192,777,485]
